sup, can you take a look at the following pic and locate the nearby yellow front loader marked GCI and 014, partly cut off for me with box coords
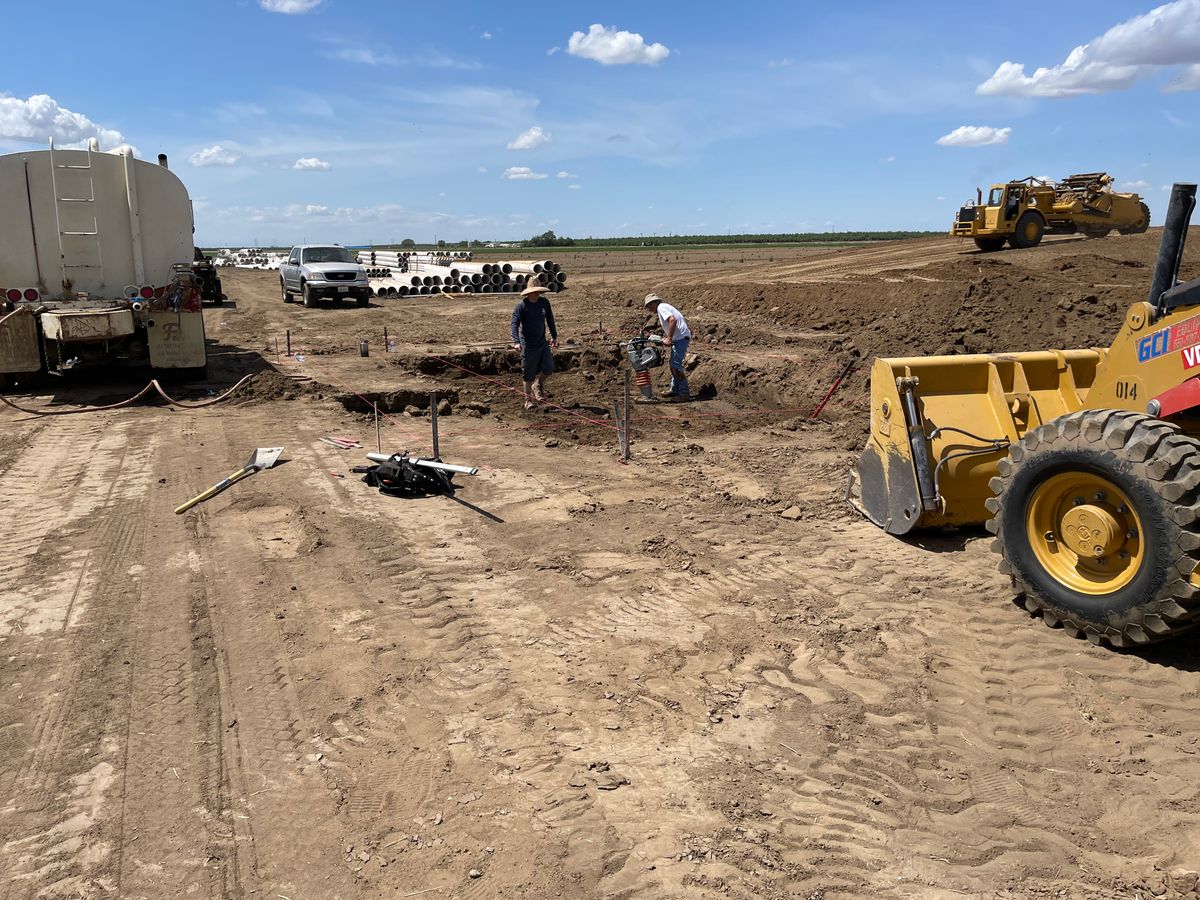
[847,184,1200,647]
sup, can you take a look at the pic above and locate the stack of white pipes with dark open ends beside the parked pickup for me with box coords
[359,251,566,298]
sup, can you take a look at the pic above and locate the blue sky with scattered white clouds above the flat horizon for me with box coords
[0,0,1200,246]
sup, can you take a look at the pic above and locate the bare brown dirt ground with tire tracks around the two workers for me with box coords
[0,232,1200,900]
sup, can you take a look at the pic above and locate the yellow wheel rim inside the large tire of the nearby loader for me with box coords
[1025,472,1145,596]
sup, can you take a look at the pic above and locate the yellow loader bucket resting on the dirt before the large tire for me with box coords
[846,349,1105,534]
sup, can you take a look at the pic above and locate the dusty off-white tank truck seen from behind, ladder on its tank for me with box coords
[0,140,206,383]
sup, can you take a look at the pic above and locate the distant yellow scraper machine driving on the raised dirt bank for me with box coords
[950,172,1150,252]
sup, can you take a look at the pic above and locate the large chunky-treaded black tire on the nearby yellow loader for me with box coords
[988,409,1200,647]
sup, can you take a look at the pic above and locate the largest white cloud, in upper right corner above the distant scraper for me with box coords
[976,0,1200,97]
